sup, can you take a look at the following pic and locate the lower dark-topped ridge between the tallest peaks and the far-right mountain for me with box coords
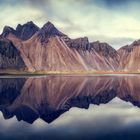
[66,37,119,71]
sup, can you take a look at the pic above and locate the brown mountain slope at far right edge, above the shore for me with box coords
[118,40,140,72]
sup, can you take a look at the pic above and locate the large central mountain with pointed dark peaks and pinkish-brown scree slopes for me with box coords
[2,22,117,72]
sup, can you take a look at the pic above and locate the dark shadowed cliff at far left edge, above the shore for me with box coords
[0,38,26,70]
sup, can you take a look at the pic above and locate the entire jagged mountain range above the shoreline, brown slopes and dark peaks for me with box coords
[0,21,140,73]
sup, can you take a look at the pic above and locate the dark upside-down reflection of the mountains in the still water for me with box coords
[0,76,140,123]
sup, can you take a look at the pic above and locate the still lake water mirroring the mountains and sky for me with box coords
[0,75,140,140]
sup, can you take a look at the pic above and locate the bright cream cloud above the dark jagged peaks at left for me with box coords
[0,6,46,31]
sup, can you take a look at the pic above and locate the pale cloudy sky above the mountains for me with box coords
[0,0,140,49]
